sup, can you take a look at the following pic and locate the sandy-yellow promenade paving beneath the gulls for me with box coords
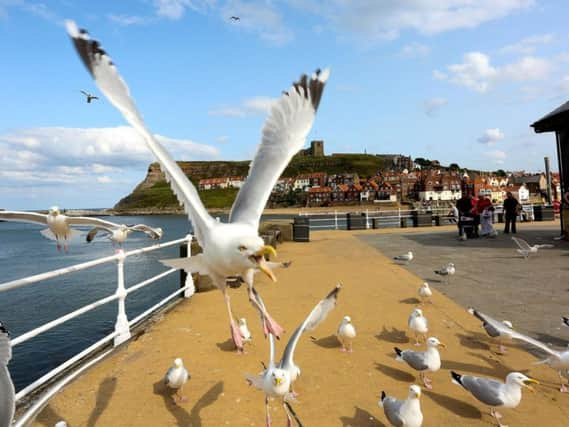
[34,231,569,427]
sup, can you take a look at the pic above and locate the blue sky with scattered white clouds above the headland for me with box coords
[0,0,569,210]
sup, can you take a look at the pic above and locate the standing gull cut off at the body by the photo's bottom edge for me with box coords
[377,384,423,427]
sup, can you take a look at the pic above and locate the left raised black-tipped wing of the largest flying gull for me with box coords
[66,21,214,244]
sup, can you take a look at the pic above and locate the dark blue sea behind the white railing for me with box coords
[0,215,291,390]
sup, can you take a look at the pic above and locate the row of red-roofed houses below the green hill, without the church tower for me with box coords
[199,169,561,206]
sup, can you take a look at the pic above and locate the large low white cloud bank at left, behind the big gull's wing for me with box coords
[0,126,218,185]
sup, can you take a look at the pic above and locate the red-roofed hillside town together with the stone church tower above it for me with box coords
[198,141,561,207]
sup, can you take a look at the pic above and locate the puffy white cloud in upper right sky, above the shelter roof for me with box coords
[433,52,553,93]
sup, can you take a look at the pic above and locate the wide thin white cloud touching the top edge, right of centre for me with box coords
[289,0,535,40]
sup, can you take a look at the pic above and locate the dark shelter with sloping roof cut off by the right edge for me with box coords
[531,102,569,240]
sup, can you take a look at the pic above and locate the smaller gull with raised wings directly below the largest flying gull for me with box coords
[246,284,341,426]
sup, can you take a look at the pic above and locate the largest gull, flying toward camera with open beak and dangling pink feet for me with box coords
[67,21,330,349]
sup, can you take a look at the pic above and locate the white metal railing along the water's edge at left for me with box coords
[0,235,195,426]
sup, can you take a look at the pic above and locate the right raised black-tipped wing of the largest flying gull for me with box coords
[229,69,330,229]
